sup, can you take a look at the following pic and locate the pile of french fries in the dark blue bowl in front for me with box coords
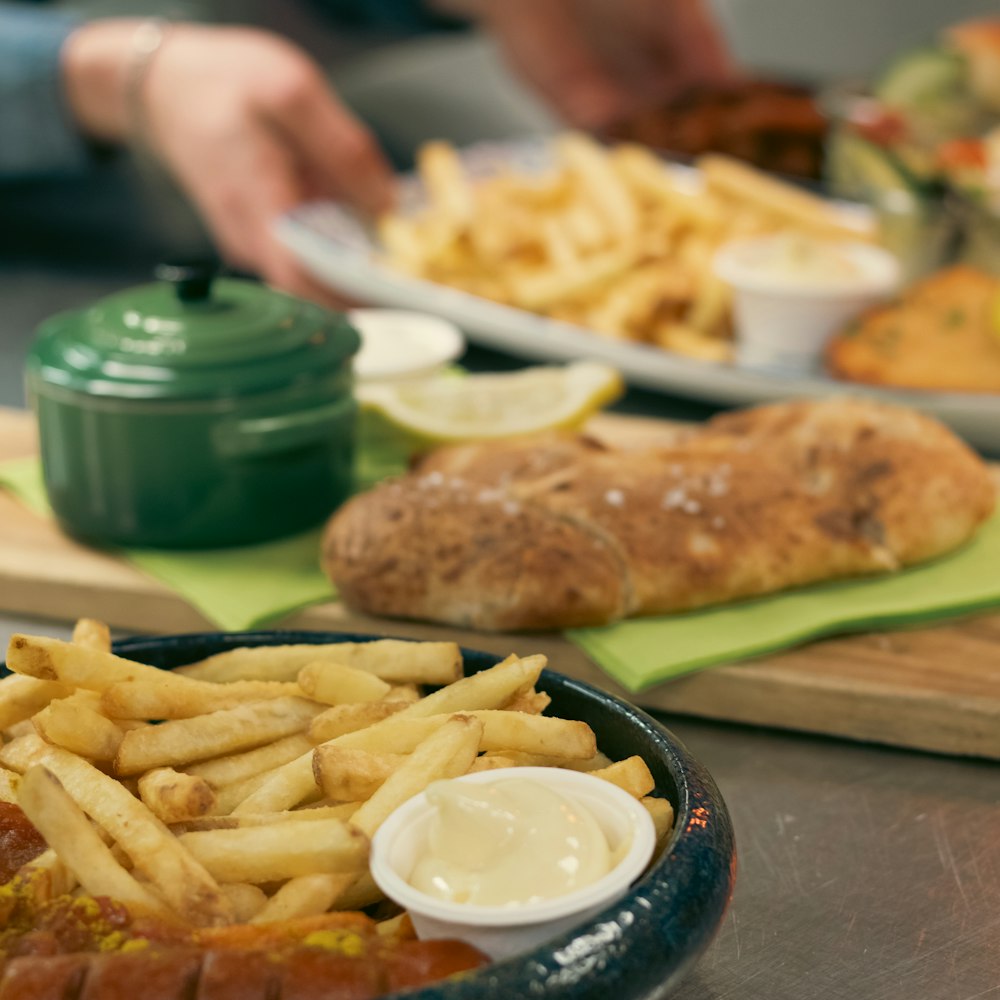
[0,620,673,927]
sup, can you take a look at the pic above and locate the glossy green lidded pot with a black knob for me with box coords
[27,266,360,548]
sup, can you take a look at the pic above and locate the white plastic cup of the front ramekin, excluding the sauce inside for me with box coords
[369,767,656,959]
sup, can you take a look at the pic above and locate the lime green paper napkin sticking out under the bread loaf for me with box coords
[567,513,1000,691]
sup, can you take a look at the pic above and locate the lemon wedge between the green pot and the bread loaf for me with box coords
[357,361,624,445]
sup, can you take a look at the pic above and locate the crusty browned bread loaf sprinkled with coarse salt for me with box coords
[323,399,994,630]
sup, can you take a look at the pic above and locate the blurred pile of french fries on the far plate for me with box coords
[379,133,873,361]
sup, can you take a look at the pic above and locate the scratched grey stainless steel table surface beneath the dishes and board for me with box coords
[0,247,1000,1000]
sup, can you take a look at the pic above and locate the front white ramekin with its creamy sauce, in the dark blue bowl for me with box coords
[370,767,656,959]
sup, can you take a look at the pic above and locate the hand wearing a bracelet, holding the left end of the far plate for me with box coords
[63,21,392,298]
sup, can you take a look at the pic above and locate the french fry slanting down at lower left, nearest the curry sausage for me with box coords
[18,765,172,919]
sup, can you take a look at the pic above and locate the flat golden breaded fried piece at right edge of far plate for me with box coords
[827,267,1000,392]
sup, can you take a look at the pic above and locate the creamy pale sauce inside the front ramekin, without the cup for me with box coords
[409,778,616,906]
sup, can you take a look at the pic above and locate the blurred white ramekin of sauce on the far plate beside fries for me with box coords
[714,233,900,376]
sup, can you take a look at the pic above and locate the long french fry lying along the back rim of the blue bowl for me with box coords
[177,639,462,684]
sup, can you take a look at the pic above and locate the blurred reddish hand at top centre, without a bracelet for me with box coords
[435,0,733,128]
